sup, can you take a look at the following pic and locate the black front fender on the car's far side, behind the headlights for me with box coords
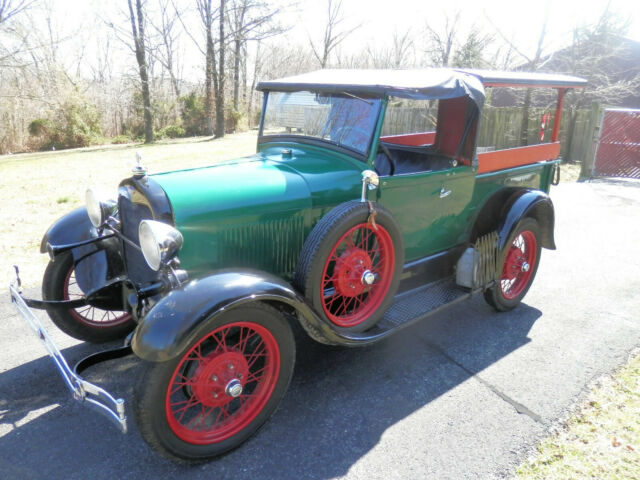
[40,207,125,294]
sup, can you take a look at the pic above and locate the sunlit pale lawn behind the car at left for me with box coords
[0,132,257,287]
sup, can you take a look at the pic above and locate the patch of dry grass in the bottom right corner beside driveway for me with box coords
[516,352,640,480]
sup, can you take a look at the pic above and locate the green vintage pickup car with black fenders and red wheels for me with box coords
[10,69,585,461]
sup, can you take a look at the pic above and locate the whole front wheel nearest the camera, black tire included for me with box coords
[134,302,295,462]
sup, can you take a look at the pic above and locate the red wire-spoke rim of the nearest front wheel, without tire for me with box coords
[165,322,280,445]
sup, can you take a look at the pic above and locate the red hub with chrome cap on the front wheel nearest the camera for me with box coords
[193,351,249,407]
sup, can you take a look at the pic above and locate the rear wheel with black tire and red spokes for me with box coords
[484,218,542,312]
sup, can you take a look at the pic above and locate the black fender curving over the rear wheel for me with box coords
[498,189,556,251]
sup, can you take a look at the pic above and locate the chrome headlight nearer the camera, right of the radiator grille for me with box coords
[138,220,183,270]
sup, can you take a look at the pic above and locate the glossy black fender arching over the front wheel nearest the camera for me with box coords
[131,269,316,362]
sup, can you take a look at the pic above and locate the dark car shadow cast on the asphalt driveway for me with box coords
[0,298,541,479]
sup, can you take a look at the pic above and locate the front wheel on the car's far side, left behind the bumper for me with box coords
[42,252,136,343]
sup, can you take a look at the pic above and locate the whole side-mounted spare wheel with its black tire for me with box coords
[294,200,404,332]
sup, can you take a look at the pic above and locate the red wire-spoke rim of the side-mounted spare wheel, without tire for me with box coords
[320,223,395,328]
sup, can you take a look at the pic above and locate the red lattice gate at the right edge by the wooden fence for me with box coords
[593,109,640,178]
